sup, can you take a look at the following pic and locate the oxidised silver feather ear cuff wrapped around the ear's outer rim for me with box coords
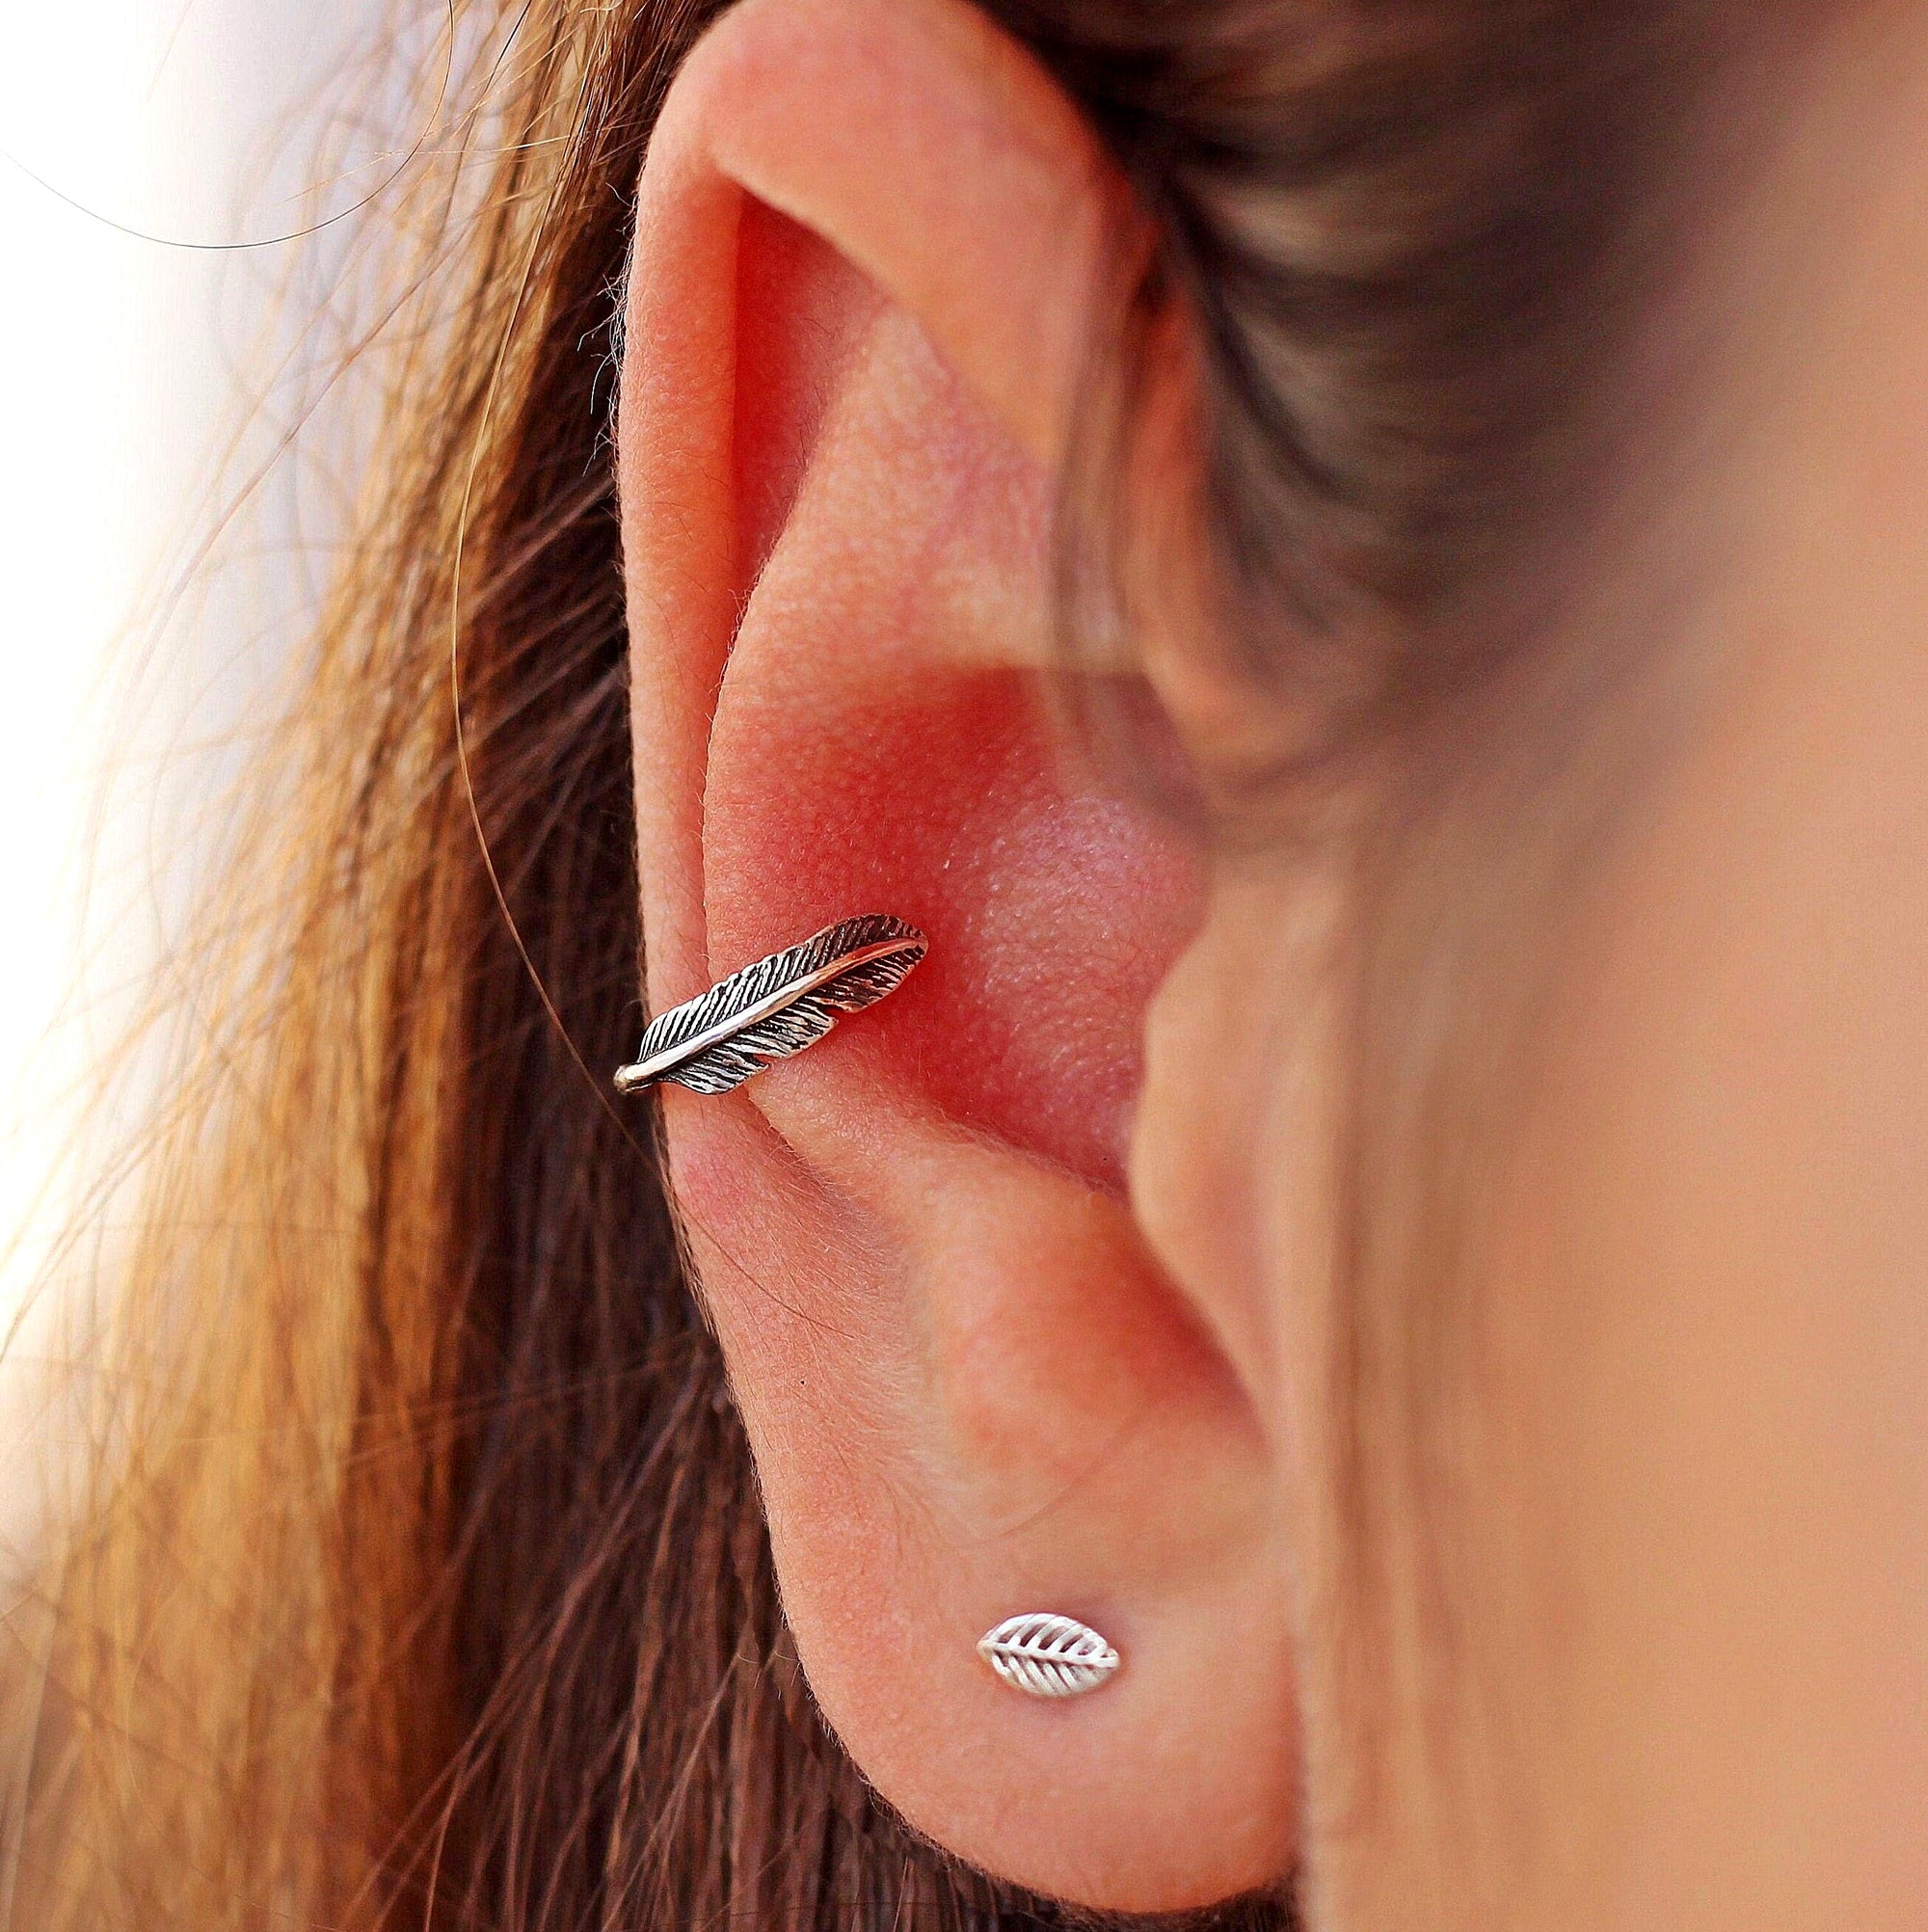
[616,912,929,1093]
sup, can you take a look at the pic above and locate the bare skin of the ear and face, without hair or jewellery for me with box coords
[620,0,1928,1932]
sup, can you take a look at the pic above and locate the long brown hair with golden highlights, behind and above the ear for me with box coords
[19,0,1738,1932]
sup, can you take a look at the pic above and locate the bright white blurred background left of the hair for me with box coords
[0,0,418,1530]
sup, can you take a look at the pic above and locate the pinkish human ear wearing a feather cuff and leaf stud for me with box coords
[618,0,1297,1911]
